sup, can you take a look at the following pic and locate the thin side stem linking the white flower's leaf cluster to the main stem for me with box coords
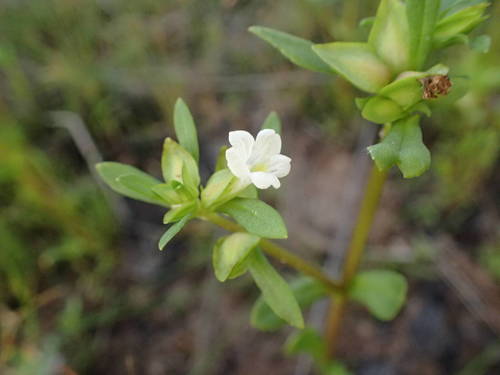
[200,213,343,294]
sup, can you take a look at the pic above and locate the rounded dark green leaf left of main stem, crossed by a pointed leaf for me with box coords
[250,277,328,331]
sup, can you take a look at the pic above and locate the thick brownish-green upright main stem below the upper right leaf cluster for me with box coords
[326,165,387,357]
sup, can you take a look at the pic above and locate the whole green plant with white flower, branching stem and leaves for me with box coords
[97,0,489,374]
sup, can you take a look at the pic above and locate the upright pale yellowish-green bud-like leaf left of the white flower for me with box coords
[161,138,200,198]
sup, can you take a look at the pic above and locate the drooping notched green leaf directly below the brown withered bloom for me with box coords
[368,115,431,178]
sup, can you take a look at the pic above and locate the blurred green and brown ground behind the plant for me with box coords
[0,0,500,375]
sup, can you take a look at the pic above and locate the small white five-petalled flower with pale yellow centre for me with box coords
[226,129,291,189]
